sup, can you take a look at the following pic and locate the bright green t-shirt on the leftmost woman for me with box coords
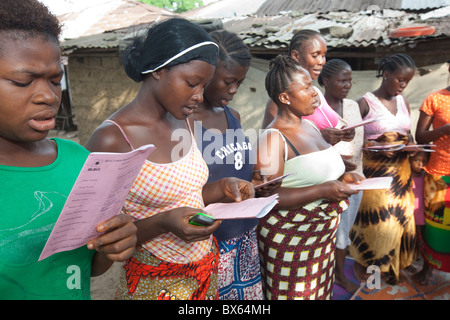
[0,138,95,300]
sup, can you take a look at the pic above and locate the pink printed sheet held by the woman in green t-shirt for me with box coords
[39,145,155,261]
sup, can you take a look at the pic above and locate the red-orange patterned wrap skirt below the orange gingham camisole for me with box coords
[116,241,219,300]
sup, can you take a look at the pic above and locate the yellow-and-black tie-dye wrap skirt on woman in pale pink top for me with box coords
[349,132,416,282]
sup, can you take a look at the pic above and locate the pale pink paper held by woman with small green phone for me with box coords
[207,194,278,219]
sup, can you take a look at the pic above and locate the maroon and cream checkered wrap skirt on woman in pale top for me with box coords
[257,200,348,300]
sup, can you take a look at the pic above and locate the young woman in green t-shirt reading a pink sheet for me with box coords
[0,0,136,300]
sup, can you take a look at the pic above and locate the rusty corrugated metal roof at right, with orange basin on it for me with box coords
[224,10,450,52]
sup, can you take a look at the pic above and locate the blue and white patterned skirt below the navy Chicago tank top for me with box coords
[219,227,263,300]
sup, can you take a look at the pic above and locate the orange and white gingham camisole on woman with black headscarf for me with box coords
[119,126,212,263]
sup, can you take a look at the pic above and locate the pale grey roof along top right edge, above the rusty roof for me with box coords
[255,0,450,16]
